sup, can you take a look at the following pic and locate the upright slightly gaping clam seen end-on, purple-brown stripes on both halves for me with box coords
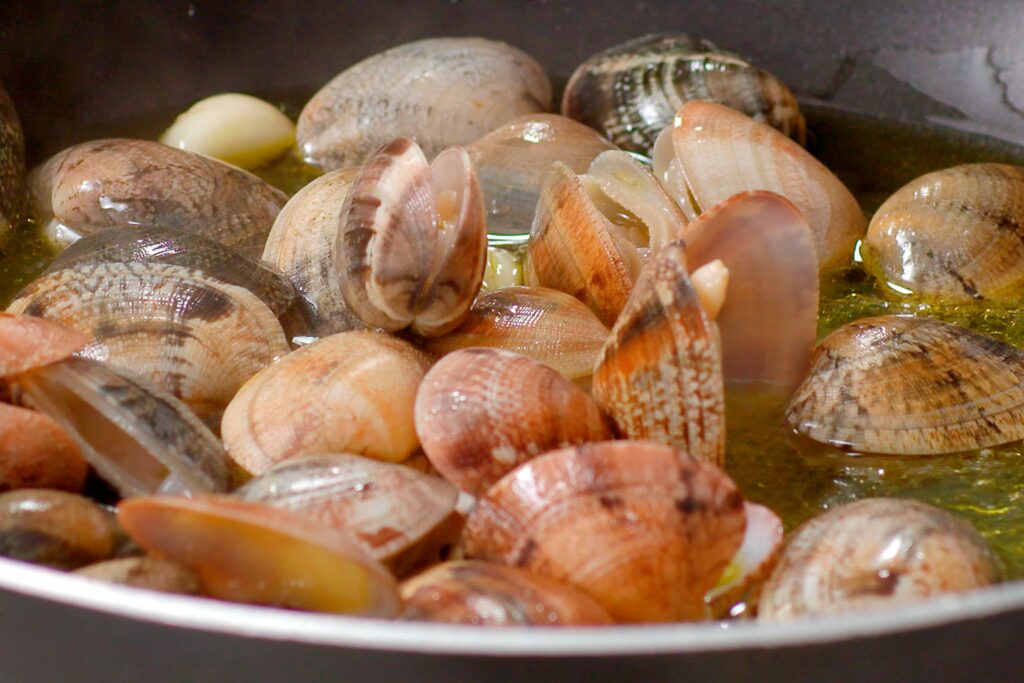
[335,138,487,337]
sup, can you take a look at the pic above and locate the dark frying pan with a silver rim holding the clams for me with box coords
[0,0,1024,683]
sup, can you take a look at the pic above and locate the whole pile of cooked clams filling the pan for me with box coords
[0,35,1024,627]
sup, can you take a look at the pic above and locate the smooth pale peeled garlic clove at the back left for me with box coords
[160,92,295,169]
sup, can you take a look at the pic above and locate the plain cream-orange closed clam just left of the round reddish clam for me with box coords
[221,331,430,474]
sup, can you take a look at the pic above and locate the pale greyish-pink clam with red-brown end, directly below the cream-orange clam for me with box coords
[234,454,462,577]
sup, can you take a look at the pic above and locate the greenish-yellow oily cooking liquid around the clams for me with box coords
[6,100,1024,579]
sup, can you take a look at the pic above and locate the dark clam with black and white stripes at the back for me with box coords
[562,34,807,155]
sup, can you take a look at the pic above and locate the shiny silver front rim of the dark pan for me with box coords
[0,559,1024,656]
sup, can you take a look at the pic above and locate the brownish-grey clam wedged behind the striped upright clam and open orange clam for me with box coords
[466,114,615,241]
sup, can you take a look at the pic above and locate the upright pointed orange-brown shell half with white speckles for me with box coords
[593,242,725,465]
